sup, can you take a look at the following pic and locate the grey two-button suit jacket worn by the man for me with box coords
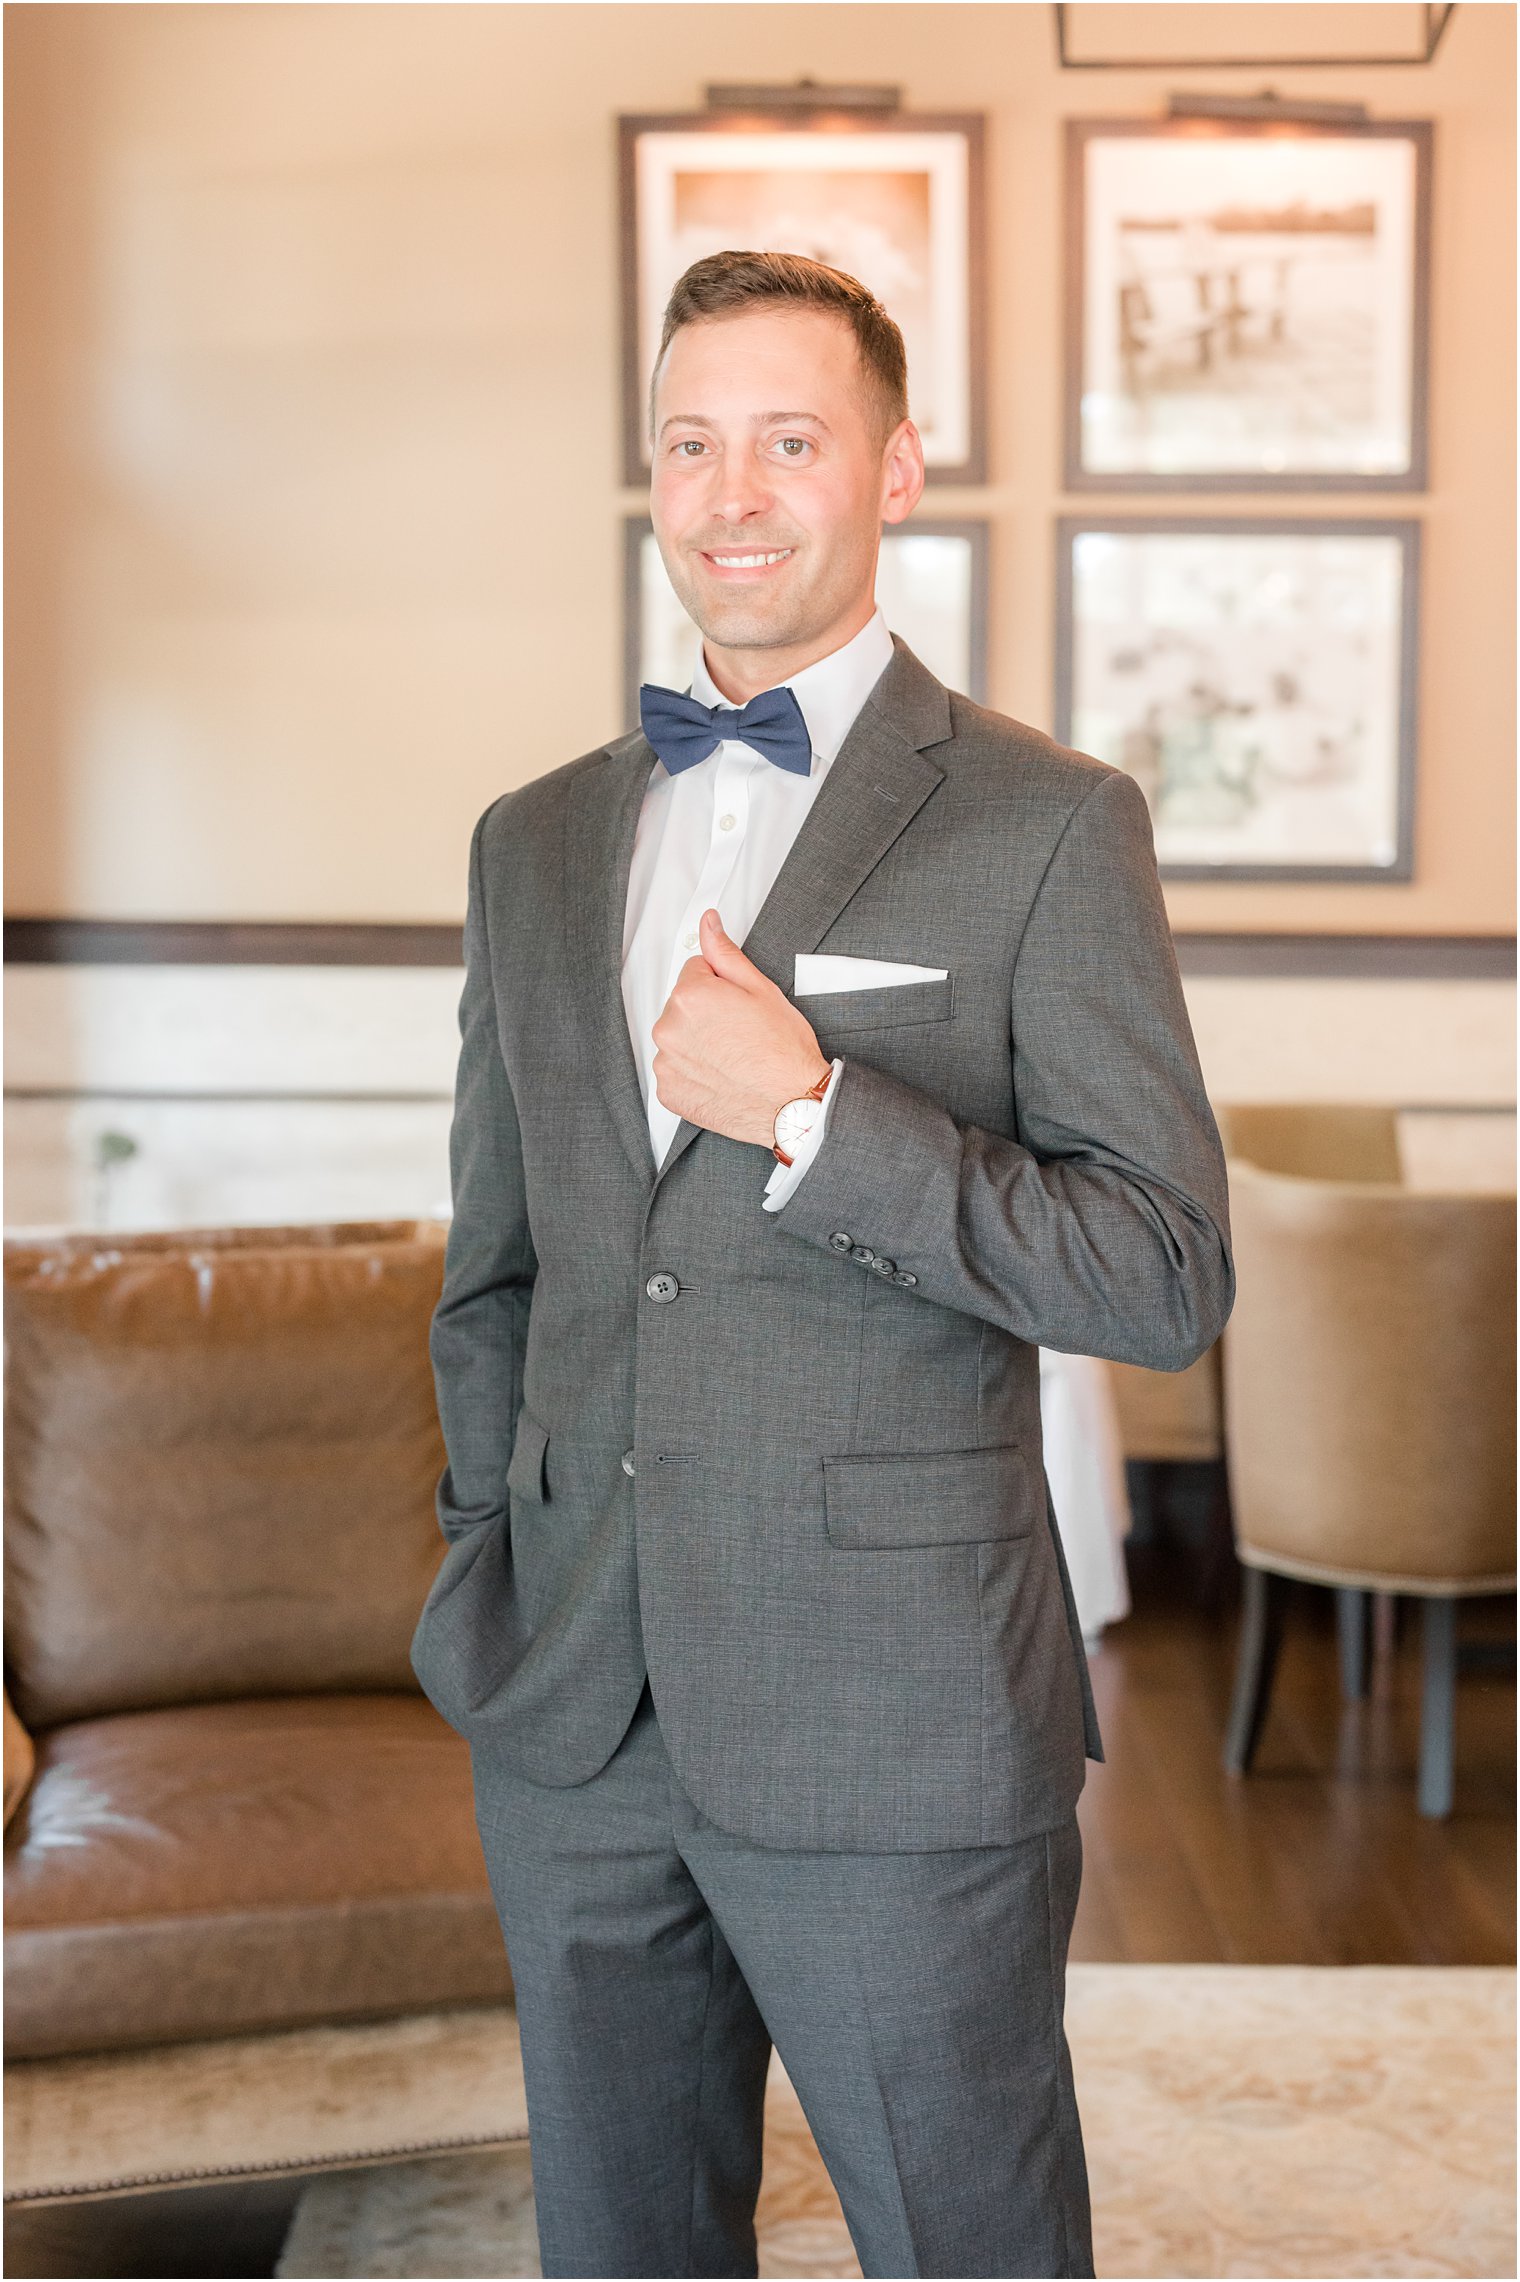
[413,641,1235,1851]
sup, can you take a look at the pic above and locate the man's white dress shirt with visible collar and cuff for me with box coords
[623,612,892,1212]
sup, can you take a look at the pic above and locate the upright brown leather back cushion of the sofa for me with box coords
[5,1221,445,1732]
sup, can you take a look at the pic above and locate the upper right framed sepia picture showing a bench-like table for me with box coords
[1066,119,1431,491]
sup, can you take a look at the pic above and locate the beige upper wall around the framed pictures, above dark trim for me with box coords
[5,5,1513,933]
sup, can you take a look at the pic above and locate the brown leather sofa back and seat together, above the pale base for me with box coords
[5,1221,511,2058]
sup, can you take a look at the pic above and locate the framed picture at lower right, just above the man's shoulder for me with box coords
[1054,516,1420,881]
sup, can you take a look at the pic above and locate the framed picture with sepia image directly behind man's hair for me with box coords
[618,112,986,484]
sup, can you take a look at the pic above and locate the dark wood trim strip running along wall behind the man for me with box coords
[5,920,1515,981]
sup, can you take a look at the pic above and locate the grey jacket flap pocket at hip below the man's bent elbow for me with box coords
[824,1442,1034,1552]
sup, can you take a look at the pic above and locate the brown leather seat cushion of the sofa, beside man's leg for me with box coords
[5,1693,511,2058]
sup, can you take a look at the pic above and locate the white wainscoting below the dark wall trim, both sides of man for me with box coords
[5,965,1515,1230]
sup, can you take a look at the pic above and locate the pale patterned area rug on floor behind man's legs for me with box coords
[278,1965,1515,2282]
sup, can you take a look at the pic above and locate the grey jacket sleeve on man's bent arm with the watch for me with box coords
[776,769,1235,1371]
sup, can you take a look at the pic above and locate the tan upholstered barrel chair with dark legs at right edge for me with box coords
[1219,1107,1515,1814]
